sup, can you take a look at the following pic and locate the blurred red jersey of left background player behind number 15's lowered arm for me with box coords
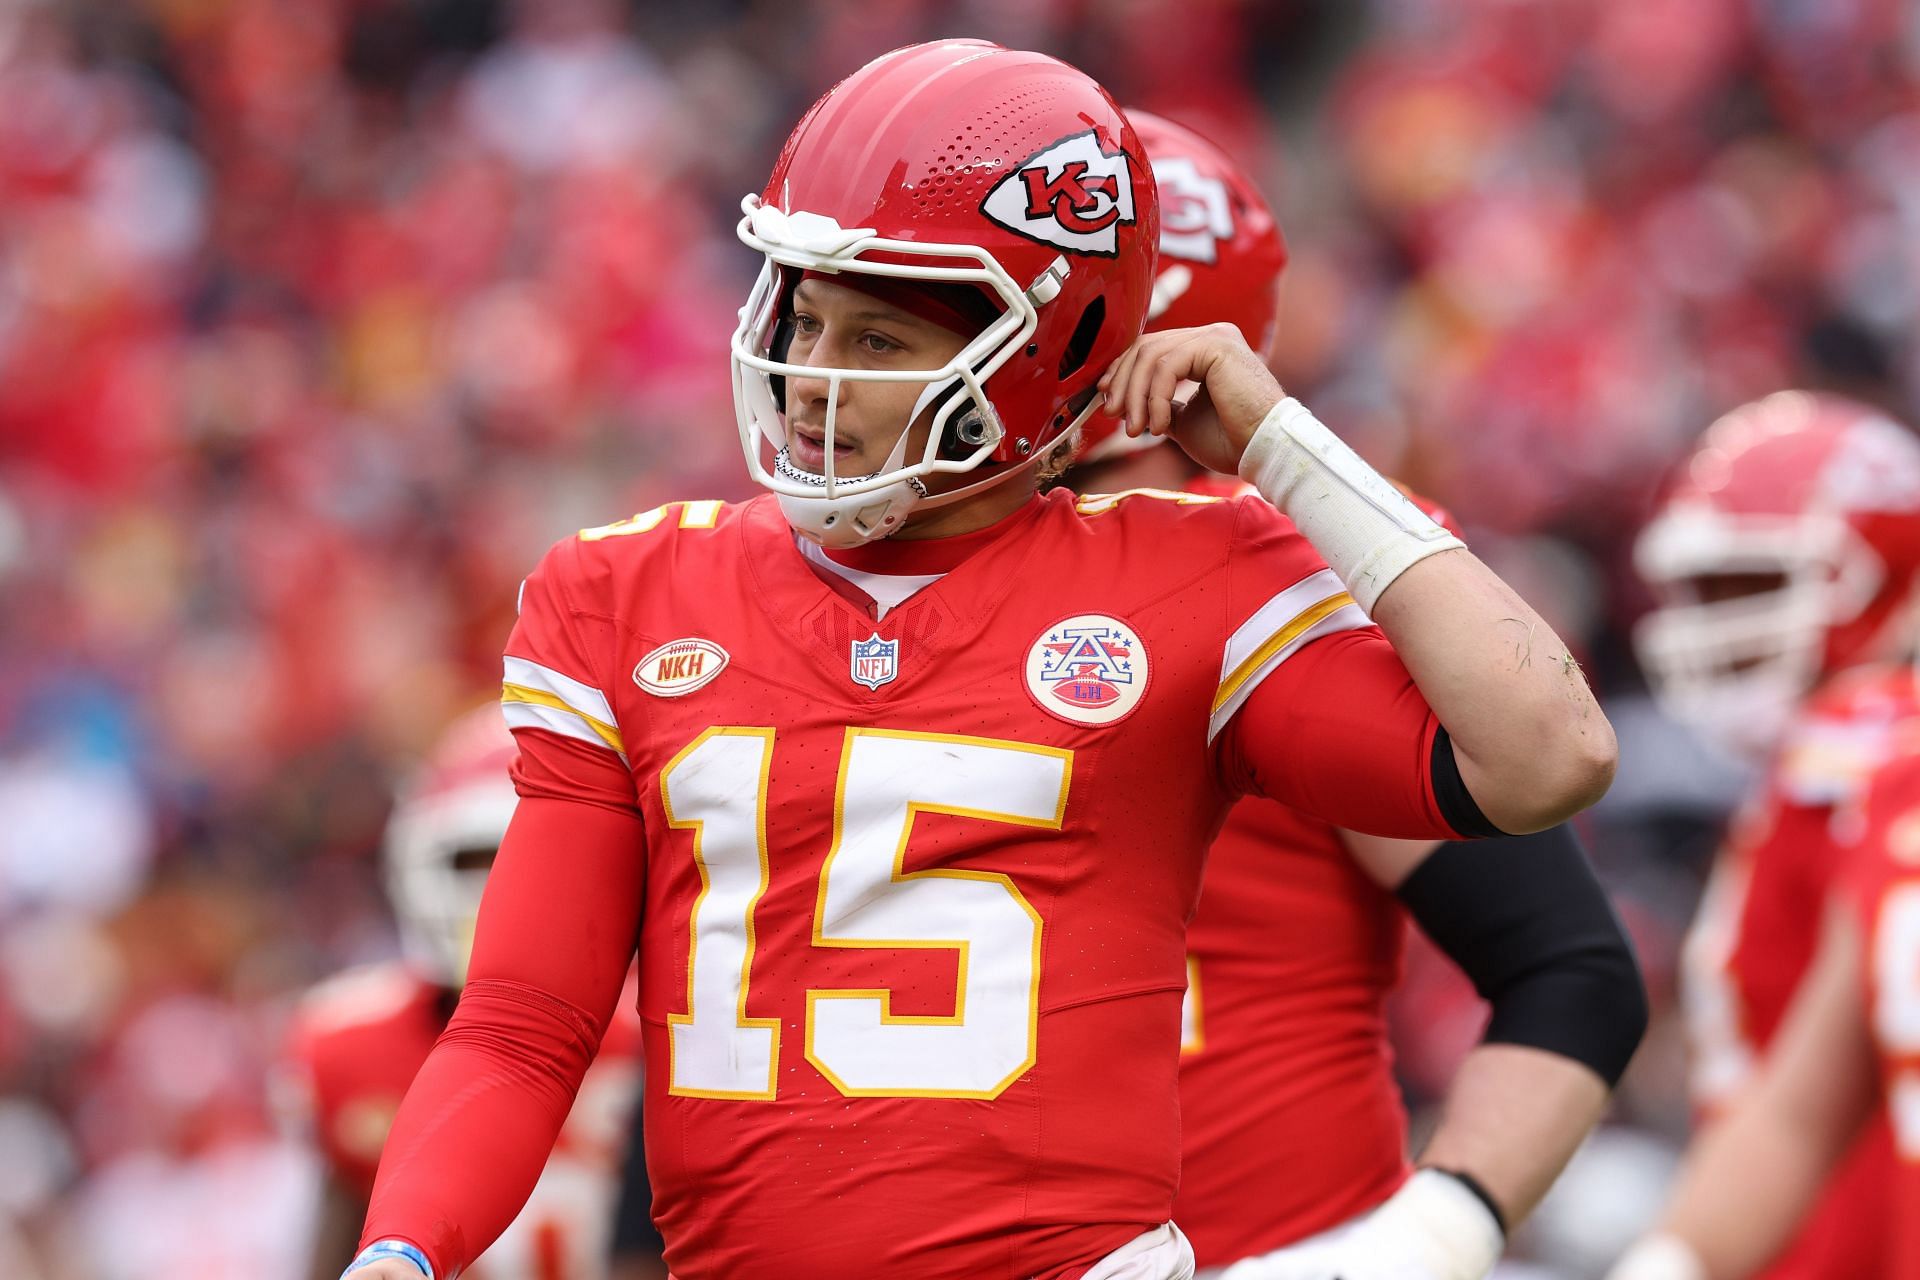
[286,963,639,1280]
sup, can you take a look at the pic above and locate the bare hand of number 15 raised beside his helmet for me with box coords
[1100,324,1286,476]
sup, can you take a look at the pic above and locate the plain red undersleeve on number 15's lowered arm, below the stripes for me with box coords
[361,798,645,1276]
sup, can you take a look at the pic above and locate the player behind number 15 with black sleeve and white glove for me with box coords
[1068,107,1647,1278]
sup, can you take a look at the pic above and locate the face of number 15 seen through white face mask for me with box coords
[787,280,966,478]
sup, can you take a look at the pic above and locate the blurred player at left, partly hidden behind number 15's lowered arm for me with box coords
[286,704,664,1280]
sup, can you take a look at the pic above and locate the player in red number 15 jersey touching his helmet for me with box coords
[337,40,1615,1280]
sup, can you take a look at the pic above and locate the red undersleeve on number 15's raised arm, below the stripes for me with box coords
[1217,628,1459,841]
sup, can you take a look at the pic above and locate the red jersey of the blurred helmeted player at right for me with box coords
[1682,666,1920,1280]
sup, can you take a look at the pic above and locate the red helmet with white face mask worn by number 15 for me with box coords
[733,40,1160,545]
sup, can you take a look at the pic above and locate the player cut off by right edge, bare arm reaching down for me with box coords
[1609,733,1920,1280]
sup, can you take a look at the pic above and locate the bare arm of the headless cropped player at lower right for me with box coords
[1609,906,1874,1280]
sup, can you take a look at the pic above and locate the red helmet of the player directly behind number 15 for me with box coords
[1079,107,1286,462]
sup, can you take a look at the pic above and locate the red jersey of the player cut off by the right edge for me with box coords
[1828,743,1920,1280]
